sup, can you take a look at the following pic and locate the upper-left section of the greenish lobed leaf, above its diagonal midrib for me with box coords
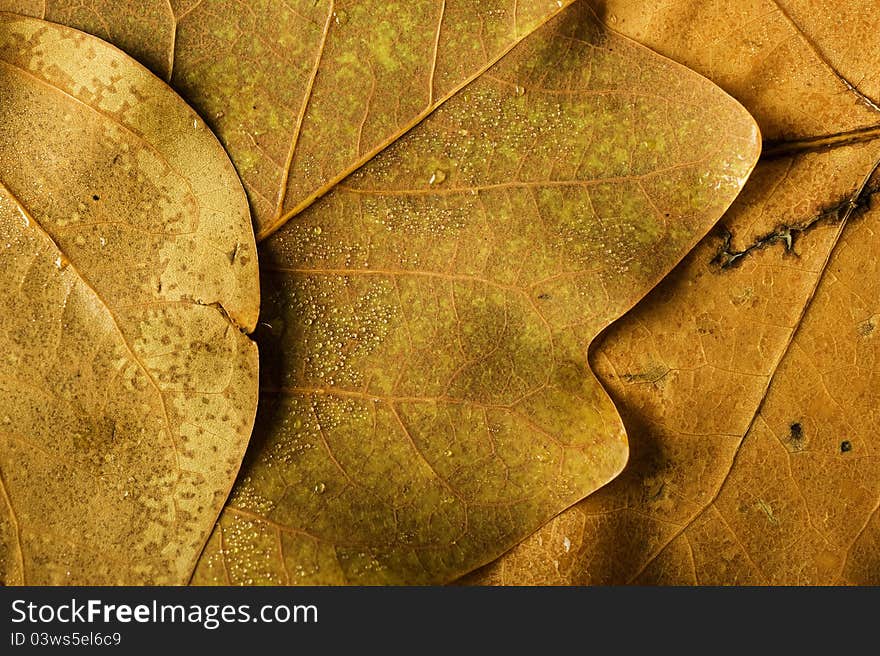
[0,0,572,238]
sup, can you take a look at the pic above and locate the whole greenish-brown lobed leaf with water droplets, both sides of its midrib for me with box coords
[0,0,784,583]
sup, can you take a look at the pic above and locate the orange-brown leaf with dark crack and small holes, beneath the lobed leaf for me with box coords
[468,0,880,584]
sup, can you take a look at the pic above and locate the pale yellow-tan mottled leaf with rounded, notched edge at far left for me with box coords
[0,14,259,584]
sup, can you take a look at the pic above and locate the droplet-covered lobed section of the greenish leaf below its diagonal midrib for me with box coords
[194,3,758,584]
